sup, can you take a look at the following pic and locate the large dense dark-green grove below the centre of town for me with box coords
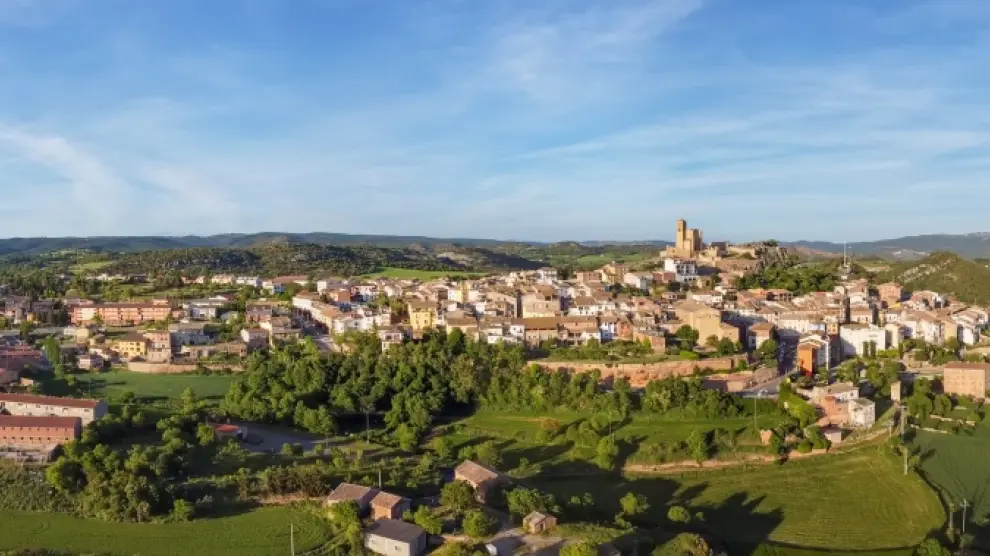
[221,331,523,447]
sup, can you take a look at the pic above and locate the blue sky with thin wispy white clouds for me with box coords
[0,0,990,241]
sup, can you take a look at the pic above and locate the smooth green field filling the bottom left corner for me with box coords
[0,508,330,556]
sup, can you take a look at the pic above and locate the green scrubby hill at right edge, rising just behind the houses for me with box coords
[878,252,990,304]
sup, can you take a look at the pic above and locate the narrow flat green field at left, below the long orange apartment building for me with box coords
[76,371,234,400]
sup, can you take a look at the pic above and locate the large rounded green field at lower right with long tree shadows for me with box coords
[531,445,945,554]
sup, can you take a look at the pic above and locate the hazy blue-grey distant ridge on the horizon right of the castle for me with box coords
[796,232,990,260]
